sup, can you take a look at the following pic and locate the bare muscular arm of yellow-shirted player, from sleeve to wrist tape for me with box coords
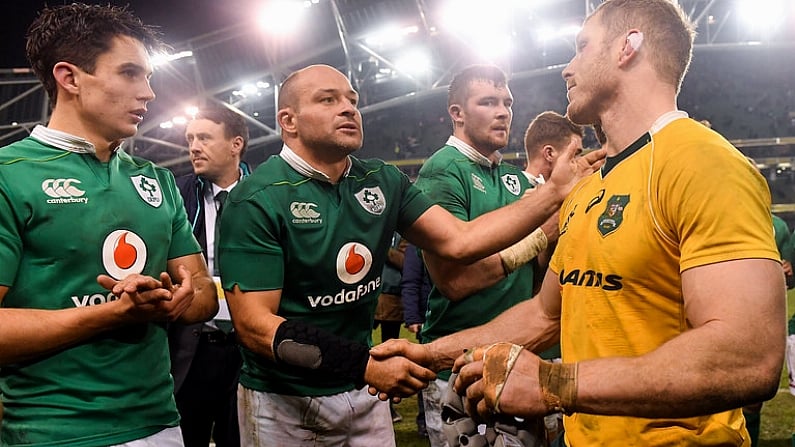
[575,259,786,417]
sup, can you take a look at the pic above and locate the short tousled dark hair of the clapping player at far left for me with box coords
[25,3,163,106]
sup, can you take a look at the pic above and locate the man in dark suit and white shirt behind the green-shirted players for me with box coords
[169,107,249,447]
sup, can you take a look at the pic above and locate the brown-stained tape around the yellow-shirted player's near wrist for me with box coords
[538,361,577,415]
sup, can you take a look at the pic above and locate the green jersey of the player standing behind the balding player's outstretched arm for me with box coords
[416,137,533,380]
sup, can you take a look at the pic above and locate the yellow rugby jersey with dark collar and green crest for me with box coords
[550,112,779,447]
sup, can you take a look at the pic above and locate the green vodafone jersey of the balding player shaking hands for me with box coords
[219,146,431,396]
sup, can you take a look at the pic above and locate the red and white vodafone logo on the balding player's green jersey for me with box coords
[307,242,381,307]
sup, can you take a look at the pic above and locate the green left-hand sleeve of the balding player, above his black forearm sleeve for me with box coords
[218,190,286,291]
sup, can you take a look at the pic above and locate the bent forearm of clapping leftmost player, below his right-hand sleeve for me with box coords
[167,253,218,324]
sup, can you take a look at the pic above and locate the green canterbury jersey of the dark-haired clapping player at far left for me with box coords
[0,127,200,446]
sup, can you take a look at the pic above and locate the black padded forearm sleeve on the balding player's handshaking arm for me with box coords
[273,320,370,388]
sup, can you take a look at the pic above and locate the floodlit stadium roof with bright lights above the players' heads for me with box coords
[0,0,795,173]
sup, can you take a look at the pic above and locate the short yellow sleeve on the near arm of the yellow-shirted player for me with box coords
[652,141,780,271]
